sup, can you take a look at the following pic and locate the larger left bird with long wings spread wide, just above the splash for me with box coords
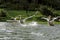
[7,11,38,24]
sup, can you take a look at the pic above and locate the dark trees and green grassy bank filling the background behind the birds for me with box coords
[0,0,60,23]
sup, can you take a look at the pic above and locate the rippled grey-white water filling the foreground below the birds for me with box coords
[0,22,60,40]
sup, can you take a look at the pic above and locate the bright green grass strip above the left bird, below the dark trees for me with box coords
[8,10,34,17]
